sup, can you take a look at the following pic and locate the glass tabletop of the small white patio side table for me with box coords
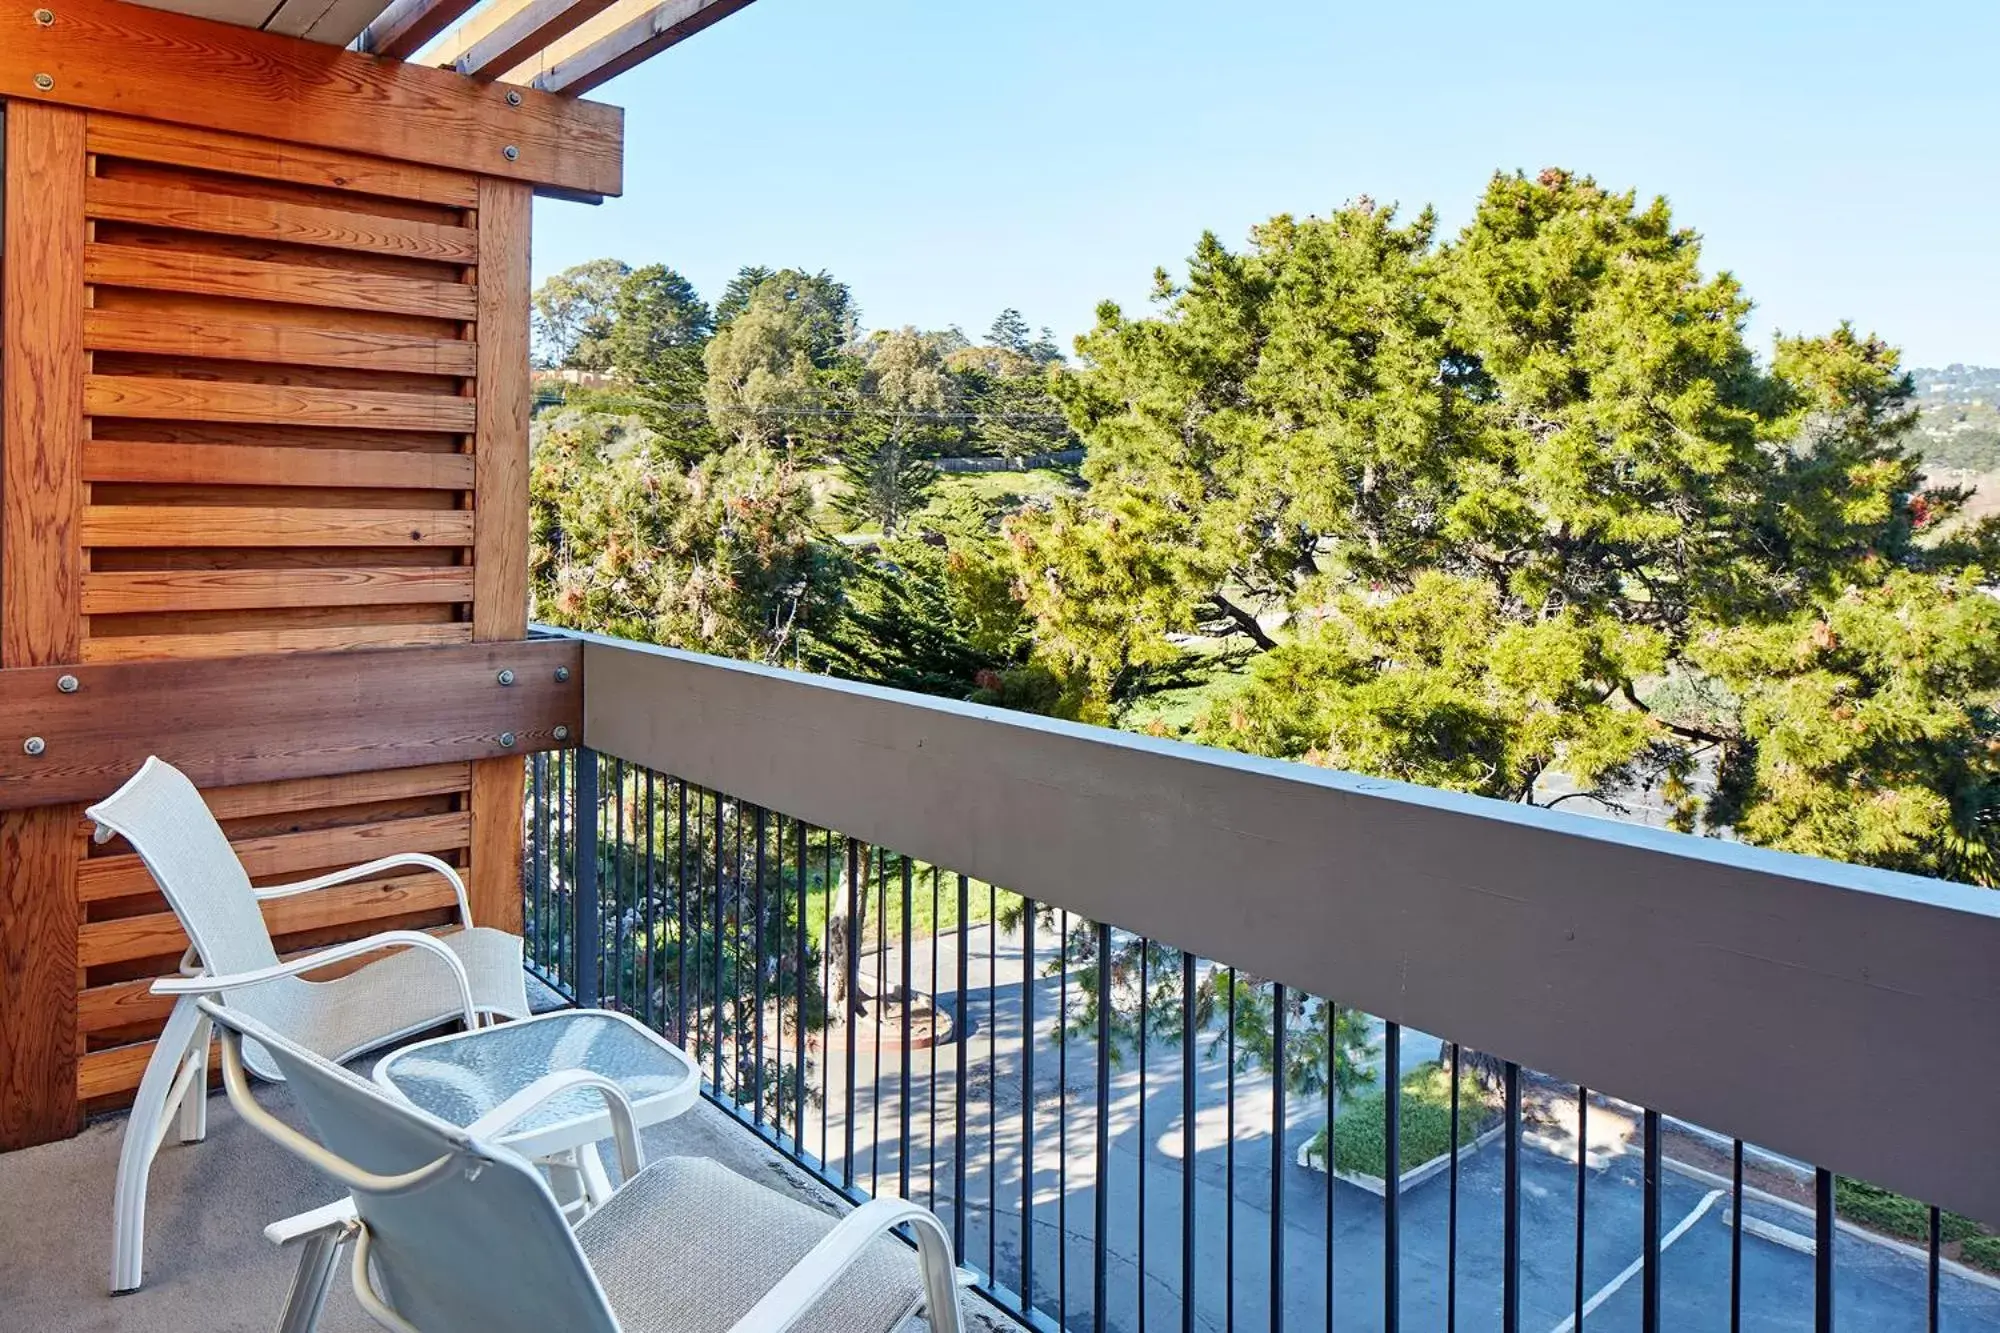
[376,1011,700,1139]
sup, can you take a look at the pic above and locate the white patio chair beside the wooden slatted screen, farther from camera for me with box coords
[88,757,528,1293]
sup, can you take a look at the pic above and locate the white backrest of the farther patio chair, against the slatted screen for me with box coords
[86,757,278,977]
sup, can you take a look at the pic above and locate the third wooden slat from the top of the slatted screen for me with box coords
[84,244,478,320]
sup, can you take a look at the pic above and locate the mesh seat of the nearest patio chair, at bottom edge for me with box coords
[576,1157,924,1333]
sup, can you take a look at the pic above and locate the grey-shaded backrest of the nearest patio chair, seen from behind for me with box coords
[202,1001,618,1333]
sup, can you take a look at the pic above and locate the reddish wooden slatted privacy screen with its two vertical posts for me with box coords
[0,102,530,1147]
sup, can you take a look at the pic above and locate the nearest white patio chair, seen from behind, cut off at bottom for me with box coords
[200,999,960,1333]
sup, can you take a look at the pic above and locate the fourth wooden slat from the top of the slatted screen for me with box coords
[84,308,478,378]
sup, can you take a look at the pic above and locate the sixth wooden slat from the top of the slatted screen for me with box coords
[84,440,474,490]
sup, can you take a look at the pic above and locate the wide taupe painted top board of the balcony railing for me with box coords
[548,636,2000,1221]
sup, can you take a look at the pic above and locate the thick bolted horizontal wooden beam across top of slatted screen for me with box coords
[0,0,624,194]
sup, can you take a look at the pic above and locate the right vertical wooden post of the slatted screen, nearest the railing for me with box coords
[466,180,530,933]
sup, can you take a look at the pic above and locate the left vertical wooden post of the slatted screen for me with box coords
[0,106,84,1149]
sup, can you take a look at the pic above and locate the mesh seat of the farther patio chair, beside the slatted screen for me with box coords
[228,927,530,1081]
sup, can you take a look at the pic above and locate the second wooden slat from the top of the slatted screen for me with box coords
[84,176,478,264]
